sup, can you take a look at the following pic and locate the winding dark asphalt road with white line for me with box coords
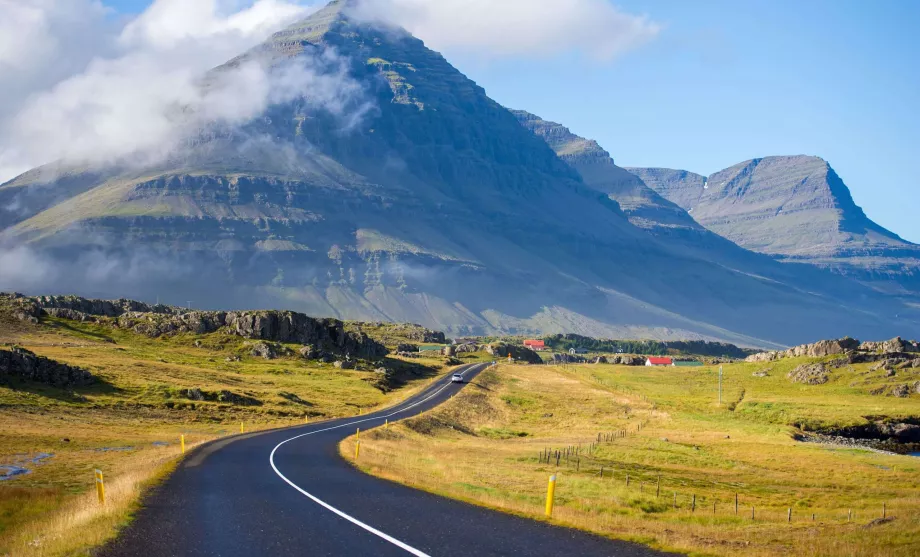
[99,364,665,557]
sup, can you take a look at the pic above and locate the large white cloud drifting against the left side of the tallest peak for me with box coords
[0,0,370,183]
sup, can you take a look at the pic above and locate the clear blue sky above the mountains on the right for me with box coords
[105,0,920,242]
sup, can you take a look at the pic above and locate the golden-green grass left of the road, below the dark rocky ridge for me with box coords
[0,308,454,556]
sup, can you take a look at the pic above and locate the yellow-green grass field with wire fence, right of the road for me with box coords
[341,360,920,556]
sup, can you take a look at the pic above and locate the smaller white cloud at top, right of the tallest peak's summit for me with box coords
[357,0,661,61]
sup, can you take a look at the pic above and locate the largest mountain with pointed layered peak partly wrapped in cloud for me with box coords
[0,2,918,347]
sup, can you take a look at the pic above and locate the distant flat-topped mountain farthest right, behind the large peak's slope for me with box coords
[629,156,920,294]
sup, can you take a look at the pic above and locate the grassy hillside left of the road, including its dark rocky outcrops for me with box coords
[0,294,460,556]
